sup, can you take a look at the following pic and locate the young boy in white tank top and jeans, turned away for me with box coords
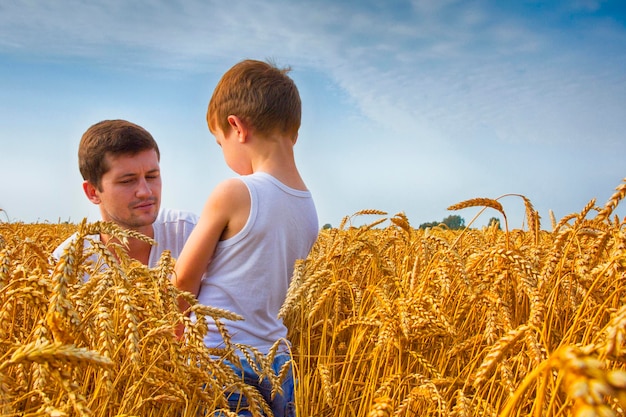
[173,60,318,416]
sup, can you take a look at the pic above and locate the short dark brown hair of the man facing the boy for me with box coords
[78,119,161,191]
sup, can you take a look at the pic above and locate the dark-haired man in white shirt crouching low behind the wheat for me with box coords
[53,120,197,272]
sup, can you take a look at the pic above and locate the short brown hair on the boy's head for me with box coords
[207,60,302,139]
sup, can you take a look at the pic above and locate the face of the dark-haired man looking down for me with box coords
[83,149,161,232]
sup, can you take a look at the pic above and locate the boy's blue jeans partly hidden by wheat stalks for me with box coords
[217,353,296,417]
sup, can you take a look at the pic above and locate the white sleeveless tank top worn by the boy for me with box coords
[198,172,319,353]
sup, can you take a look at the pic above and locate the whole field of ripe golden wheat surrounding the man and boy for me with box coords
[0,179,626,417]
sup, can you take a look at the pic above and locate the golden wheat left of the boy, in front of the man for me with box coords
[0,222,268,416]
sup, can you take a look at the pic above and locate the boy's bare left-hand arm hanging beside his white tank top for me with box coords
[172,178,250,311]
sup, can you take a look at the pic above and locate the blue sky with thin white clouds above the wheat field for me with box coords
[0,0,626,228]
